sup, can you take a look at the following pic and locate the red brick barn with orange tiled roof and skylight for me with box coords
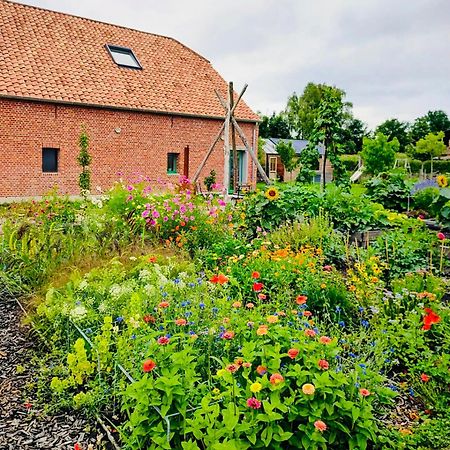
[0,0,258,199]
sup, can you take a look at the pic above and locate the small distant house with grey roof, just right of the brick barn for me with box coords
[263,138,333,182]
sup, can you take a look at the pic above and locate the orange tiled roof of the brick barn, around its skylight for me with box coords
[0,0,258,121]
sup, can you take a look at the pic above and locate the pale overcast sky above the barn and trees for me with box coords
[14,0,450,128]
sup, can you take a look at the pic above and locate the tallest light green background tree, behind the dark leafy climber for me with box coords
[285,82,352,139]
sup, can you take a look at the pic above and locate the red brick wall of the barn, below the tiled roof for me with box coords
[0,99,257,197]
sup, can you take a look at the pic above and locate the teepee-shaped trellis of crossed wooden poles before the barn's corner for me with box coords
[193,82,270,198]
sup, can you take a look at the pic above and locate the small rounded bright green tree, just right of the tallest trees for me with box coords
[361,133,400,175]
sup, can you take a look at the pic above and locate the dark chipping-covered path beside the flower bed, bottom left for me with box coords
[0,299,105,450]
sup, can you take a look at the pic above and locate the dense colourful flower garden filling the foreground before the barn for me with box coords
[0,177,450,450]
